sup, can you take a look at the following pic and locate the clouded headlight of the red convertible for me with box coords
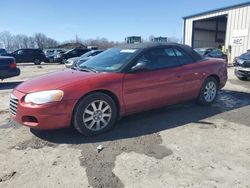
[24,90,63,104]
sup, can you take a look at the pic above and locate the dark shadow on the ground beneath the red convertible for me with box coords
[31,90,250,144]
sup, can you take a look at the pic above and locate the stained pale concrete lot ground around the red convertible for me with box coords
[0,64,250,187]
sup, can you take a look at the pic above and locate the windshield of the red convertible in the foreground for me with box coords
[80,48,138,72]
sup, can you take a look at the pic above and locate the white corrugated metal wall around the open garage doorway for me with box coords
[184,5,250,62]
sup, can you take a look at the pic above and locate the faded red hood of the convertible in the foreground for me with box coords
[16,69,101,93]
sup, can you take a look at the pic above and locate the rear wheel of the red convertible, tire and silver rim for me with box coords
[198,77,219,106]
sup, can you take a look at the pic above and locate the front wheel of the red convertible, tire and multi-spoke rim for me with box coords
[73,92,118,136]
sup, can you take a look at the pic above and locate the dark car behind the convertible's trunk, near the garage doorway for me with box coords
[194,47,227,61]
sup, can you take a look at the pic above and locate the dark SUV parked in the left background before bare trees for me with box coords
[4,49,46,65]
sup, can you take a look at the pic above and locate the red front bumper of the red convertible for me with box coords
[10,90,77,130]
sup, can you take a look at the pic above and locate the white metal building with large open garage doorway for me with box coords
[183,2,250,63]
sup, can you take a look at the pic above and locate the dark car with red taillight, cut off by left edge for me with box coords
[0,56,20,80]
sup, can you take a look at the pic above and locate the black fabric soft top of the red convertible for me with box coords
[117,42,203,61]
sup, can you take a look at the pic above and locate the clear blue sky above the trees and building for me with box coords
[0,0,246,41]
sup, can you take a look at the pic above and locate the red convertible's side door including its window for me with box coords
[123,48,183,114]
